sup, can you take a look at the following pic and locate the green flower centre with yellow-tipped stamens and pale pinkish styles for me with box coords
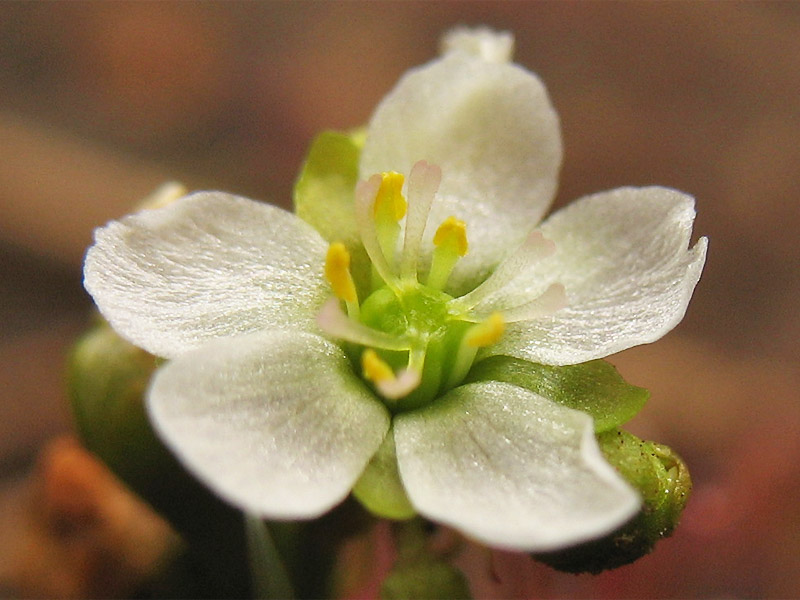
[317,161,564,412]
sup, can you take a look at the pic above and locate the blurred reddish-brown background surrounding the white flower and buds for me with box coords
[0,1,800,597]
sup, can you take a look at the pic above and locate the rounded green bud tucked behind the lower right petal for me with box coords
[534,430,692,573]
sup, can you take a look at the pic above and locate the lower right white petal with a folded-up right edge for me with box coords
[394,382,639,552]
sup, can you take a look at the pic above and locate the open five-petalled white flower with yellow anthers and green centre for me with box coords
[85,30,706,551]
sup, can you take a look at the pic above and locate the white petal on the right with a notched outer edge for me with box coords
[488,187,707,365]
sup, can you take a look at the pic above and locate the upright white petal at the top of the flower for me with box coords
[360,52,561,292]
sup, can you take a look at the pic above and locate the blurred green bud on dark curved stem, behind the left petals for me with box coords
[67,319,250,598]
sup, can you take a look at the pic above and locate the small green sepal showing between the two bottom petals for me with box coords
[353,429,417,520]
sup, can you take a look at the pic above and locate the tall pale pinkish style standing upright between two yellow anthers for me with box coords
[400,160,442,281]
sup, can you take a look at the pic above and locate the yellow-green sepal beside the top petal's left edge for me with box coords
[294,129,371,292]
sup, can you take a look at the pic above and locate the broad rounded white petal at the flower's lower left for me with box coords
[148,331,389,519]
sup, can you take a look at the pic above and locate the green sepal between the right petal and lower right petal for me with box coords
[465,356,650,433]
